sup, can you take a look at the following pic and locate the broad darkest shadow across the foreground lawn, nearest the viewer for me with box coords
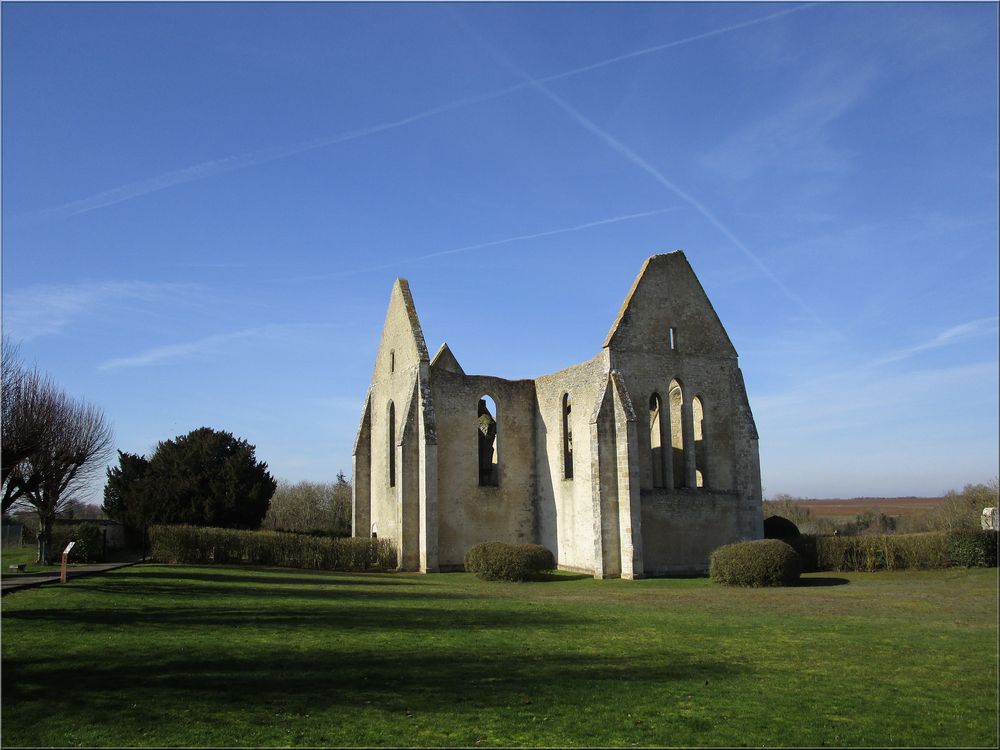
[3,644,743,725]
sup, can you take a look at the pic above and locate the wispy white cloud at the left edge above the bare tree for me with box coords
[3,281,196,341]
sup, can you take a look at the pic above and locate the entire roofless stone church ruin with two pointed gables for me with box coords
[353,252,763,578]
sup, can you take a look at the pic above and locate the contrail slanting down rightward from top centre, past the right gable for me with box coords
[461,17,830,328]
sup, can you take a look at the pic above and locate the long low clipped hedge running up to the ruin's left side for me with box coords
[149,526,396,571]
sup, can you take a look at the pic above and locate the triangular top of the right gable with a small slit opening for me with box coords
[604,251,736,357]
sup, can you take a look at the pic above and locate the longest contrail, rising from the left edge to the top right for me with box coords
[14,4,814,221]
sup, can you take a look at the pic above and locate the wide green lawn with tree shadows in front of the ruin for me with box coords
[2,565,998,747]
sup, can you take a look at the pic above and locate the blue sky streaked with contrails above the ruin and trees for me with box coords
[2,2,998,500]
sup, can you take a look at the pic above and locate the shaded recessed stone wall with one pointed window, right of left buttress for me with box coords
[431,368,535,570]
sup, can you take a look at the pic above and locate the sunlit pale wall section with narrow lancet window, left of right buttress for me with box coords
[535,350,608,573]
